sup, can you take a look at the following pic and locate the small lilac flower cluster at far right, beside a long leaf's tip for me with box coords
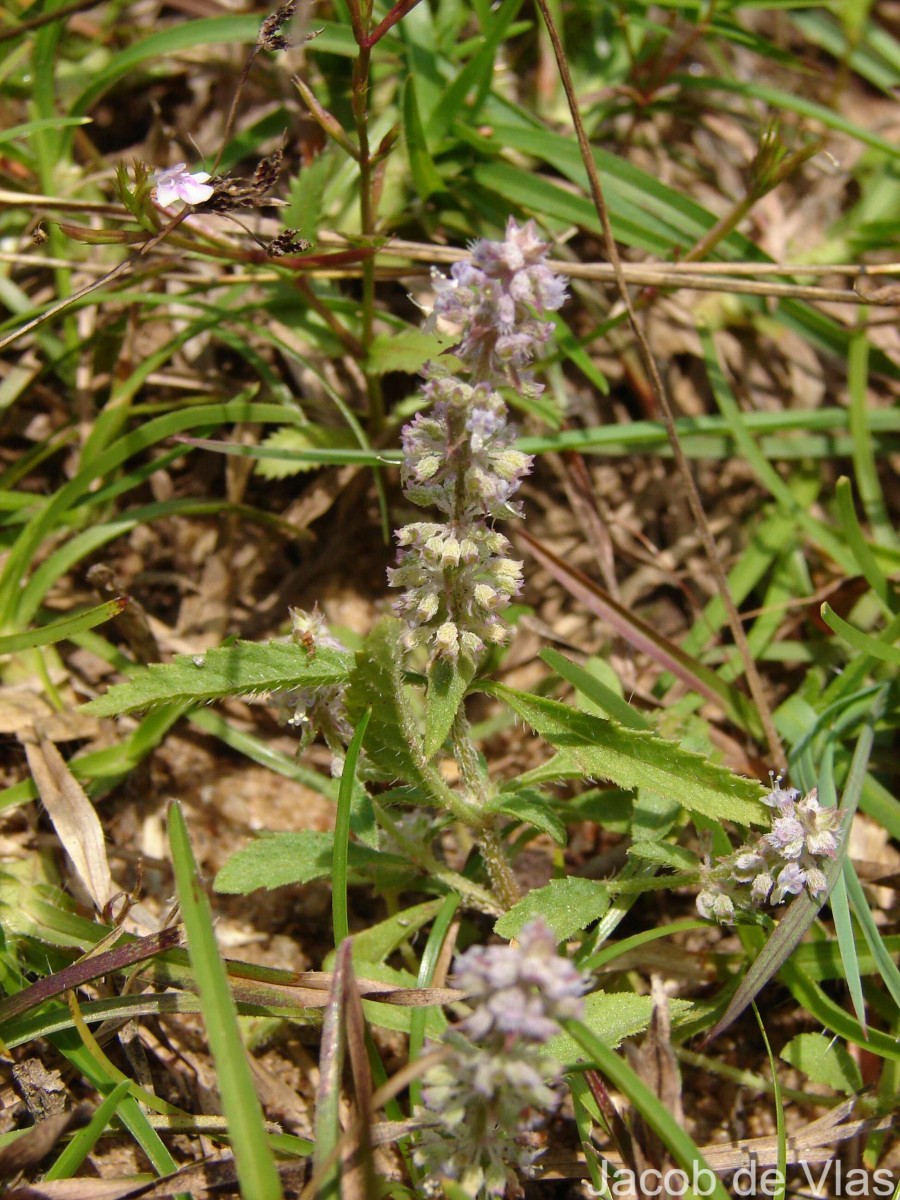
[697,779,841,922]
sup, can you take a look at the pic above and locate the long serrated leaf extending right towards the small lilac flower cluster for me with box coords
[484,683,767,824]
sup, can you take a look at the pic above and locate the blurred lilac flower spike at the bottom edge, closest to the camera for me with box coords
[413,920,589,1200]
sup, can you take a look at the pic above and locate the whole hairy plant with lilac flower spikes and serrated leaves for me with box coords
[84,216,840,1198]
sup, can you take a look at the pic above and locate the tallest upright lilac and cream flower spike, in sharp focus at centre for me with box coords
[389,218,566,660]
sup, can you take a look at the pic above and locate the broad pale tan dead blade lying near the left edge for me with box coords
[22,737,119,912]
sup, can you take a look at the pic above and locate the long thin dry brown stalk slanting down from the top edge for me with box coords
[538,0,785,768]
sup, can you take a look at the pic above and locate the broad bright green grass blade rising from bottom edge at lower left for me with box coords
[169,803,282,1200]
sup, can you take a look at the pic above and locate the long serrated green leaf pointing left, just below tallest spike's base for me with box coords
[84,642,353,716]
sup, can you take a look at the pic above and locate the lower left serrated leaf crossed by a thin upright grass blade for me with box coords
[214,829,415,895]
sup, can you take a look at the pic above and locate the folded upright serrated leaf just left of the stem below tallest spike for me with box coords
[347,617,430,788]
